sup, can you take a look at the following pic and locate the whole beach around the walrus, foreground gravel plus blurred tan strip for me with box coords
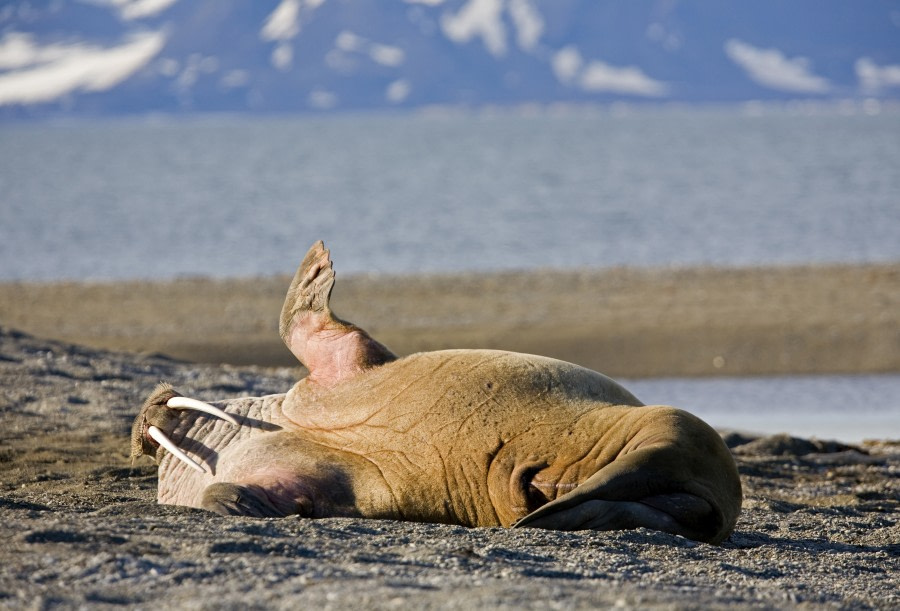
[0,265,900,609]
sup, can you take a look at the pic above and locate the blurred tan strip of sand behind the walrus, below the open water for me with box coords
[0,263,900,377]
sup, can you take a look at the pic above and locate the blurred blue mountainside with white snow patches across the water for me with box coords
[0,0,900,119]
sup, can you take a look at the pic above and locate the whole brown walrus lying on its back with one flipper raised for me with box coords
[131,241,741,543]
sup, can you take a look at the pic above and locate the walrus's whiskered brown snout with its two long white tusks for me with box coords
[131,382,239,473]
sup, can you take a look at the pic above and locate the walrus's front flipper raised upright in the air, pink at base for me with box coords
[279,240,397,387]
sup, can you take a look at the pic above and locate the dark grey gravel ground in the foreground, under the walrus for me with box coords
[0,340,900,609]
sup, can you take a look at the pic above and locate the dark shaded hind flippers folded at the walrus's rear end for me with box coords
[513,448,731,543]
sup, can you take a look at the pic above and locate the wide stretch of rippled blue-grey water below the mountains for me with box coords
[0,110,900,280]
